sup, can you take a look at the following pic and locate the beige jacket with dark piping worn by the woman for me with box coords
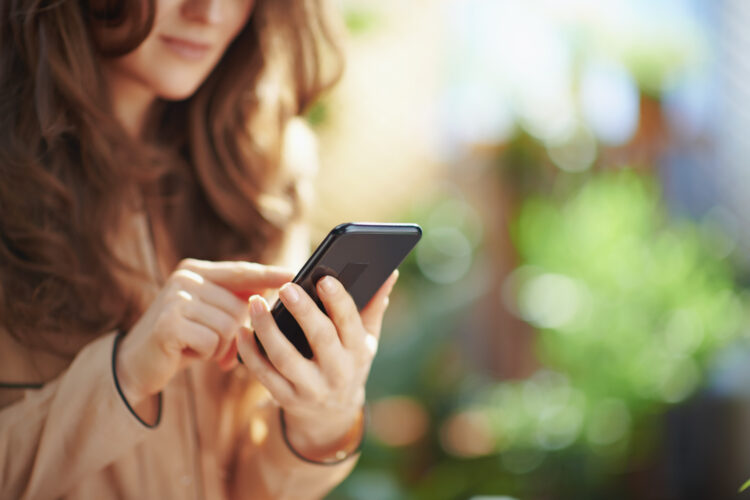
[0,125,357,500]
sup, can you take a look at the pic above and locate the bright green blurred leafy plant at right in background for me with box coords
[449,171,745,472]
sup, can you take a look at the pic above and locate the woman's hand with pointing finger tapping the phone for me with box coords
[117,259,294,405]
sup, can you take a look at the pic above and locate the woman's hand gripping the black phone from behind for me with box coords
[238,271,398,454]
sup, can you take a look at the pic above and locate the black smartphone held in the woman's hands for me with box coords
[250,222,422,359]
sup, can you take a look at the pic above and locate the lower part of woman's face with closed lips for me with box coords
[107,0,255,100]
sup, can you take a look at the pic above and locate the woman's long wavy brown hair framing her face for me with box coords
[0,0,341,355]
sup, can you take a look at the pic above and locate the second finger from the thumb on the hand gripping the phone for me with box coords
[278,283,344,375]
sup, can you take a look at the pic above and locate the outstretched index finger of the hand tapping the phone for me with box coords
[180,259,294,292]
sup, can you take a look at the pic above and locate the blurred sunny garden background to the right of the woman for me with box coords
[307,0,750,500]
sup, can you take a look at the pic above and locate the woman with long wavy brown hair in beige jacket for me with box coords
[0,0,396,499]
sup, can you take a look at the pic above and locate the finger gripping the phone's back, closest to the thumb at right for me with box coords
[316,276,365,350]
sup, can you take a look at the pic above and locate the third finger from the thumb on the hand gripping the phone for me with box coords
[247,295,315,390]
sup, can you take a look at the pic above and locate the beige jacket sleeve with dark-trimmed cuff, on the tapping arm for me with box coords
[0,333,159,499]
